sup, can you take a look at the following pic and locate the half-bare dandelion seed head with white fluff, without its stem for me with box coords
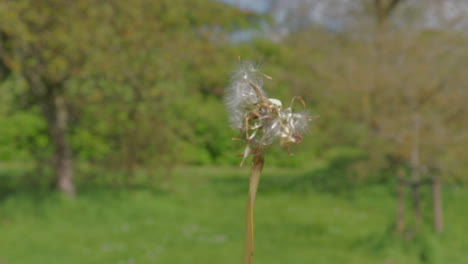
[225,62,314,164]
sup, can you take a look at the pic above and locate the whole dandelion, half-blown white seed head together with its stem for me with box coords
[225,61,313,264]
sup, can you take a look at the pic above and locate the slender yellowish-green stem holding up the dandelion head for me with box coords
[244,151,265,264]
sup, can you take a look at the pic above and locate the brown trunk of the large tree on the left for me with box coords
[49,95,75,196]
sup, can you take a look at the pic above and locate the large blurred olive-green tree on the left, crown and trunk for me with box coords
[0,0,258,195]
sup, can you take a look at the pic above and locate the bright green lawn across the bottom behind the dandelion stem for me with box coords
[0,168,468,264]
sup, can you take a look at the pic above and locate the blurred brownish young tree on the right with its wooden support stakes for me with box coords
[310,31,468,235]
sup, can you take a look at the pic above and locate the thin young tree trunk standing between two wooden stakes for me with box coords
[410,114,422,230]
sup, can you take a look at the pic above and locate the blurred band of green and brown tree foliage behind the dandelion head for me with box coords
[0,0,468,202]
